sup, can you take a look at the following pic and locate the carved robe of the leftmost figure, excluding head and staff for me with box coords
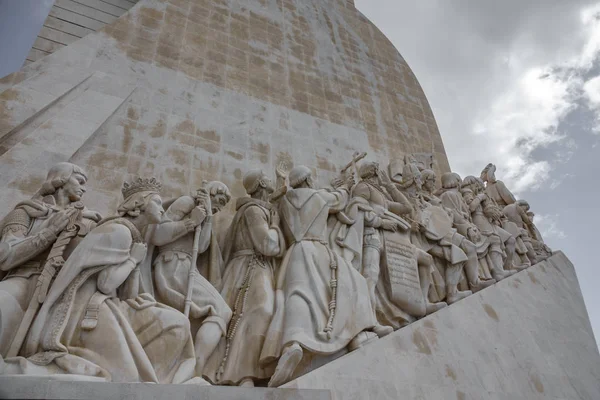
[0,196,100,356]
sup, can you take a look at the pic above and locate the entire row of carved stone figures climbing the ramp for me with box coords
[0,154,551,387]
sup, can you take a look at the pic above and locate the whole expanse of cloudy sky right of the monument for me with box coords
[356,0,600,342]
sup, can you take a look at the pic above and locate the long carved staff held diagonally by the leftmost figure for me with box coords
[7,201,83,357]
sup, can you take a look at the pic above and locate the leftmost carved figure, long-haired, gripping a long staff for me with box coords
[0,163,100,357]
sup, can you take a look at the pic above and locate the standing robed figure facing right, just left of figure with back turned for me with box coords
[207,170,286,387]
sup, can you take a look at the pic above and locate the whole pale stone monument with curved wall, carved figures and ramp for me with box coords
[0,0,600,399]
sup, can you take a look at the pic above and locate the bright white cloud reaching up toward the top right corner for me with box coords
[458,4,600,193]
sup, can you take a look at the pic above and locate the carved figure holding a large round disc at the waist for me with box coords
[400,164,495,304]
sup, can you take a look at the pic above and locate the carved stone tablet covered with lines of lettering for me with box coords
[382,232,425,309]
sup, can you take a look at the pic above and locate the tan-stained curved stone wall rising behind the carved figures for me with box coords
[0,0,449,225]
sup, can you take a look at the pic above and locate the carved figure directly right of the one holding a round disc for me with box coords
[440,172,512,281]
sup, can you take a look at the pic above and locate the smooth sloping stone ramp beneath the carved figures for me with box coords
[284,252,600,400]
